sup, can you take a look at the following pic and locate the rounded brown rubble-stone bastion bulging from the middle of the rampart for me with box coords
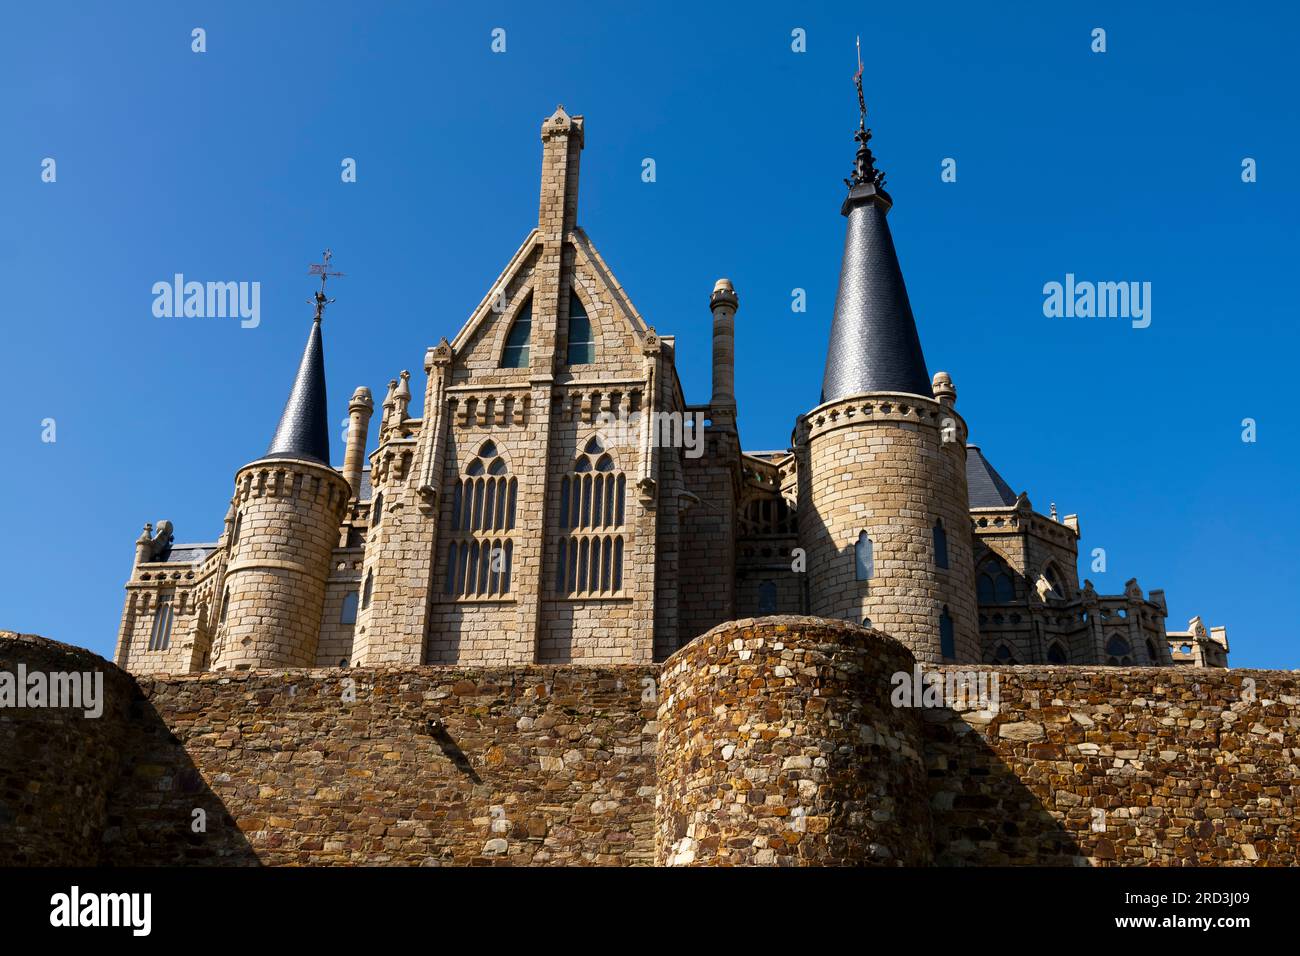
[655,617,931,866]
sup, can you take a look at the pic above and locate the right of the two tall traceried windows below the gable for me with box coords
[555,437,627,597]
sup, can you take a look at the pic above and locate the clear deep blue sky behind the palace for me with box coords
[0,1,1300,667]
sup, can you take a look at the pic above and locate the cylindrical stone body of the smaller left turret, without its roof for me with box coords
[212,458,351,671]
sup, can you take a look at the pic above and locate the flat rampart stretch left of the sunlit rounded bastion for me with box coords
[108,666,655,866]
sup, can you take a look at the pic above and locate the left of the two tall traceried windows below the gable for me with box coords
[443,441,519,598]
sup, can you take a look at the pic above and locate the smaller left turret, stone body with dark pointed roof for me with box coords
[212,284,351,670]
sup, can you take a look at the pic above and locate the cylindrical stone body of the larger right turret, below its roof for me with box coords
[797,394,979,663]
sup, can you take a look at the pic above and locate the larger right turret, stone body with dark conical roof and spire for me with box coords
[796,66,979,662]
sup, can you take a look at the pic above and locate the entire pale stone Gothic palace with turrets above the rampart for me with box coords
[116,108,1227,672]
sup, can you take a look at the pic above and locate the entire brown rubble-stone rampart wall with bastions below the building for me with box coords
[0,617,1300,866]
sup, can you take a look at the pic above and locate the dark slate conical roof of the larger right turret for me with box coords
[822,186,933,402]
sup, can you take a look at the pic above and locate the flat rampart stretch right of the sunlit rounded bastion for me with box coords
[922,666,1300,866]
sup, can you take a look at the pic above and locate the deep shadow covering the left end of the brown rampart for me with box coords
[0,632,257,866]
